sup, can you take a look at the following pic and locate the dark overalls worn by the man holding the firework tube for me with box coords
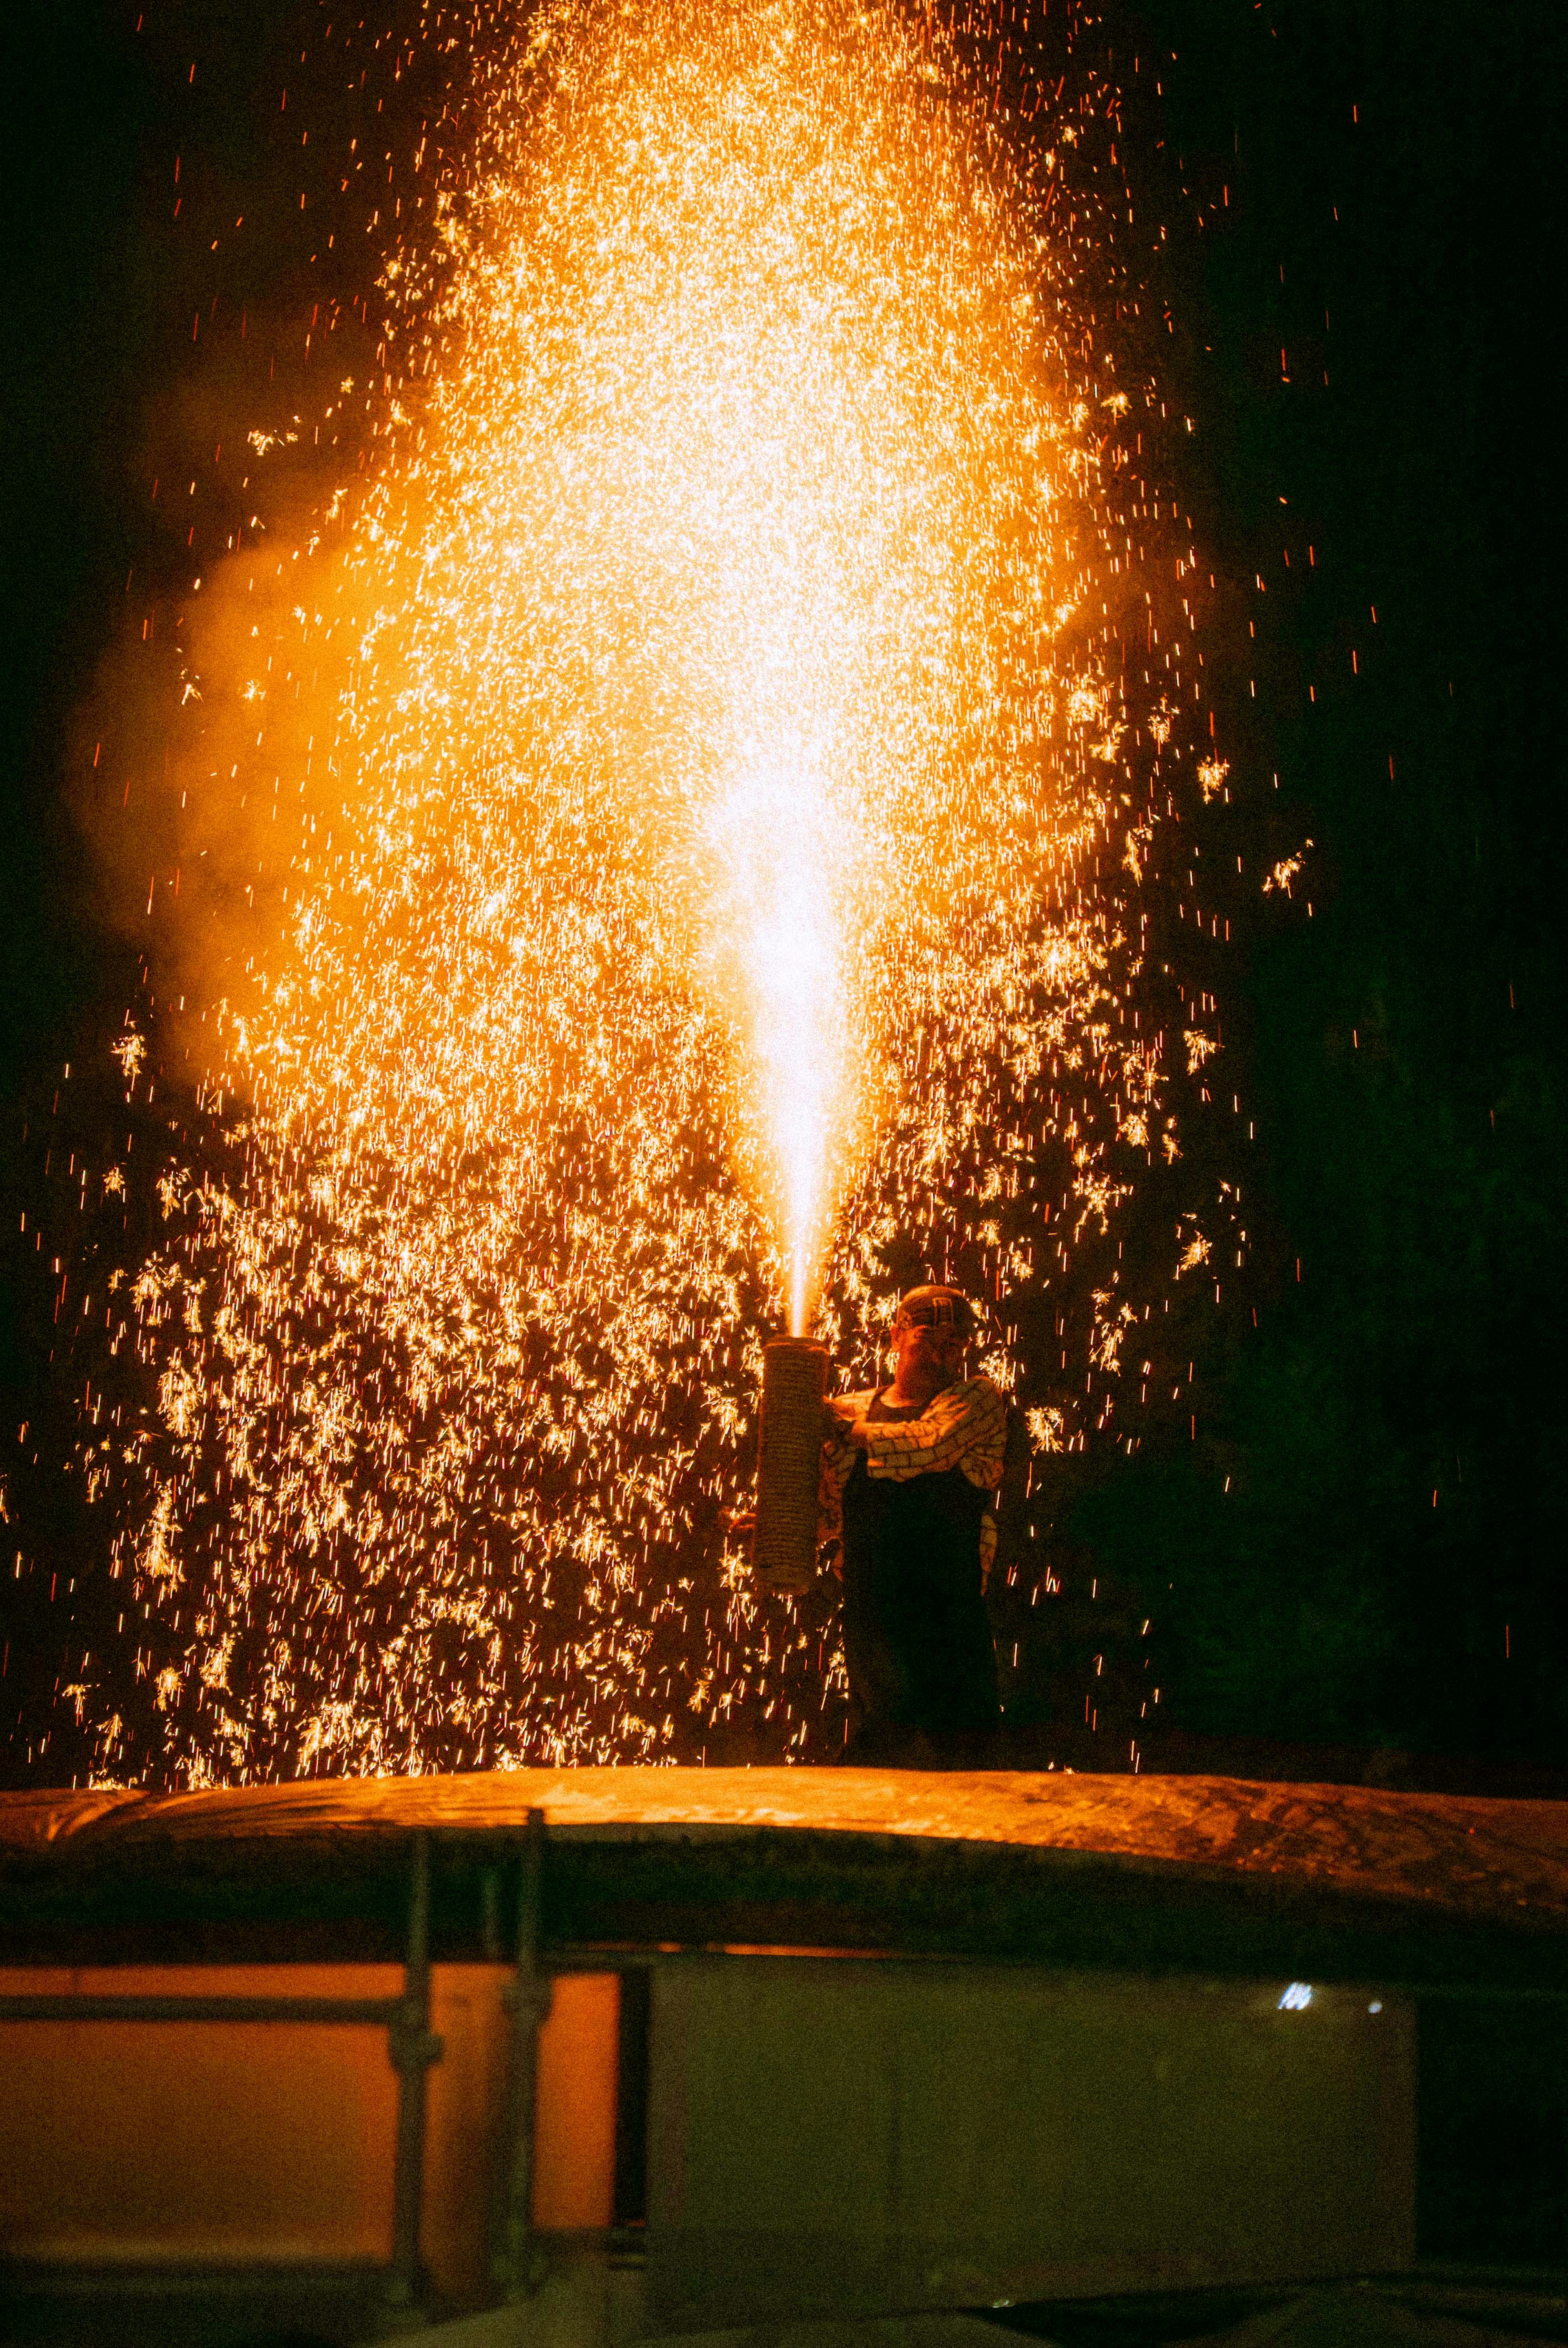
[843,1395,1000,1763]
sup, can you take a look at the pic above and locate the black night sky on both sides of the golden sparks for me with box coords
[0,0,1568,1782]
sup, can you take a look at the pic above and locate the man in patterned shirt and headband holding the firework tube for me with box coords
[819,1287,1007,1766]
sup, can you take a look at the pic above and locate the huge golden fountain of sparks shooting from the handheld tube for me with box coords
[58,0,1221,1782]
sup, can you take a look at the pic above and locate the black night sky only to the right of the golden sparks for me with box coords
[1122,4,1568,1754]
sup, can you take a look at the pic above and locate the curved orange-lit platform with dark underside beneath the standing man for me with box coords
[0,1768,1568,1989]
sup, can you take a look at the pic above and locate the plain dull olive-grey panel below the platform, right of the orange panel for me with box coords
[648,1958,1415,2329]
